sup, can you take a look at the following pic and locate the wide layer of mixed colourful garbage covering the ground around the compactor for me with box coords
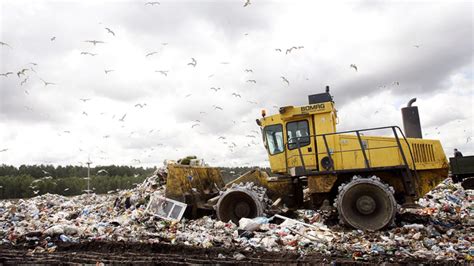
[0,175,474,261]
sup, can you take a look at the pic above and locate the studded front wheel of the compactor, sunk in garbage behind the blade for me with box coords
[216,184,269,224]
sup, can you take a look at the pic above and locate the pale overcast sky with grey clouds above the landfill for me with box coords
[0,0,474,166]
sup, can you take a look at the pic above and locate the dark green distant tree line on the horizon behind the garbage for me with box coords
[0,164,268,199]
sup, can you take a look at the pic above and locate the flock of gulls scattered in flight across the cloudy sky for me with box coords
[0,0,470,166]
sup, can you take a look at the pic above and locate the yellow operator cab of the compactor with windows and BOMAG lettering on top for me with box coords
[257,88,337,174]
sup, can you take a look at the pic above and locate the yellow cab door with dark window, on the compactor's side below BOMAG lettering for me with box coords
[285,117,317,170]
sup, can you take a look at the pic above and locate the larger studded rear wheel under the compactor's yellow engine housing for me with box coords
[336,176,397,231]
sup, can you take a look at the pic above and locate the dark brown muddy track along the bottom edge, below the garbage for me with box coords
[0,242,456,265]
